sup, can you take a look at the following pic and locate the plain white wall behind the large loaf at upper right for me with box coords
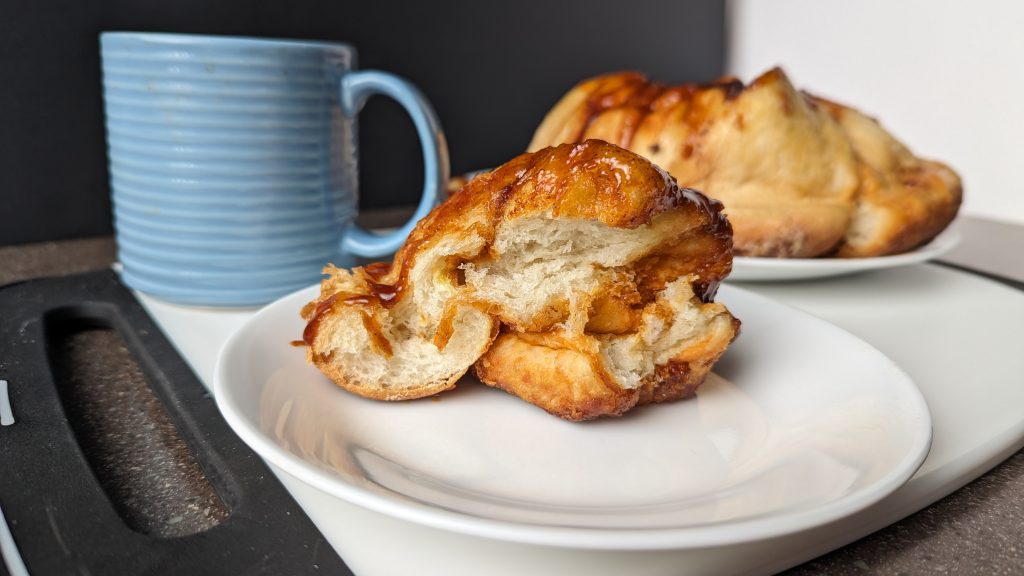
[726,0,1024,224]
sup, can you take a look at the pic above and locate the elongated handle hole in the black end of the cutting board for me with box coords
[44,304,230,538]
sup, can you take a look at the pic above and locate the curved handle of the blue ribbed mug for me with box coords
[341,70,451,258]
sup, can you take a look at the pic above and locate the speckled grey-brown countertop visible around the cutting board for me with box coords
[0,211,1024,576]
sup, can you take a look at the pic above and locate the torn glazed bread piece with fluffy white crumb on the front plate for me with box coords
[303,140,739,420]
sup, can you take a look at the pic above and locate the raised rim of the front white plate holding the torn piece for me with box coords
[213,285,933,550]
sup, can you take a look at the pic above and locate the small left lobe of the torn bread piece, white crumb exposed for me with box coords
[302,247,498,400]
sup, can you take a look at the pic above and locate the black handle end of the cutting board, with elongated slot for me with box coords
[0,271,351,576]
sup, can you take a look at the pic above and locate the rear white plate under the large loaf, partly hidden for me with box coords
[728,229,959,282]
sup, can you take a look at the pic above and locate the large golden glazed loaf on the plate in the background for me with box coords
[529,69,962,257]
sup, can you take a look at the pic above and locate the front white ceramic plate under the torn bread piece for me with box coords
[214,286,931,549]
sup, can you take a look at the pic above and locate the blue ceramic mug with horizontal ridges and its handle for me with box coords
[100,32,449,306]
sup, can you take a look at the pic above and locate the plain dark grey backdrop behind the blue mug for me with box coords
[0,0,724,242]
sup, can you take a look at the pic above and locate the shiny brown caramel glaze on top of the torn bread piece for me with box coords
[303,140,732,344]
